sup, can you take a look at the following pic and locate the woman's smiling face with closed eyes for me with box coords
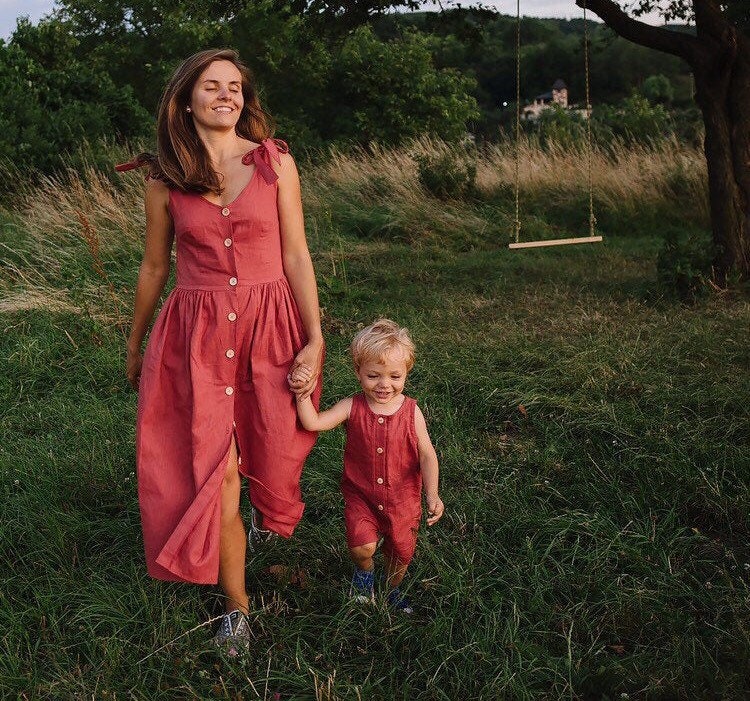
[190,61,245,131]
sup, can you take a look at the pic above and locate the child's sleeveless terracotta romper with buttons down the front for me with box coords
[341,393,422,565]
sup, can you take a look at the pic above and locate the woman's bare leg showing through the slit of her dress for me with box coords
[219,436,248,613]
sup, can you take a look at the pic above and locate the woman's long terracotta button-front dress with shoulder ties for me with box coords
[136,139,320,584]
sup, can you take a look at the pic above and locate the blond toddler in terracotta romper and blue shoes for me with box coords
[289,319,444,613]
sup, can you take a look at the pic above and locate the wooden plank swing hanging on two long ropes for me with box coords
[508,0,602,249]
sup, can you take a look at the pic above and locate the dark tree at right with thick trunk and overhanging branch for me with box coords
[575,0,750,284]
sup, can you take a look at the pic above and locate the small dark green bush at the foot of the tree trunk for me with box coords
[656,230,714,302]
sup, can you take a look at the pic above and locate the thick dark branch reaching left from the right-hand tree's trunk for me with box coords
[575,0,700,65]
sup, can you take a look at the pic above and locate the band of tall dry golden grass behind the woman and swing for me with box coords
[0,137,708,314]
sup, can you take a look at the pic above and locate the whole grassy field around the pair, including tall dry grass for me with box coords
[0,142,750,701]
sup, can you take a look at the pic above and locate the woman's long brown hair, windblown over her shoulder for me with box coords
[137,49,273,195]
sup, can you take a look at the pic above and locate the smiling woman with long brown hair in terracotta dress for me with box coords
[120,50,323,654]
